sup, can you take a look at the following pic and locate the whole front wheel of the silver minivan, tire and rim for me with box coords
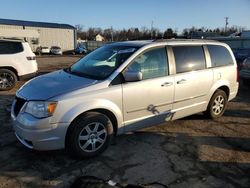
[66,112,113,158]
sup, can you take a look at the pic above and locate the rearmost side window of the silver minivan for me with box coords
[207,45,234,67]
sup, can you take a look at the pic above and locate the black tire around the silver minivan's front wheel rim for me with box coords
[67,112,113,158]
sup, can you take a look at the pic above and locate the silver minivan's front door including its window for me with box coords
[122,47,174,131]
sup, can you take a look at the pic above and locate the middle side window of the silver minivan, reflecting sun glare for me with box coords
[173,46,206,73]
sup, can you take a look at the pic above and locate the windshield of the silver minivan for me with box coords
[67,45,138,80]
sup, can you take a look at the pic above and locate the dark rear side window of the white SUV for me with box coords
[0,41,23,54]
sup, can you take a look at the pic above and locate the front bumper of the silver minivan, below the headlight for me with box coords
[11,101,69,150]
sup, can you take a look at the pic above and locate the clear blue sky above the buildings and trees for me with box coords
[0,0,250,32]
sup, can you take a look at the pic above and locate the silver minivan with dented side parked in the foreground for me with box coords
[11,40,239,157]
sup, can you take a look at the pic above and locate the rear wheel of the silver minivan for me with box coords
[205,89,228,119]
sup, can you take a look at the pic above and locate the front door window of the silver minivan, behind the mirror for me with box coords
[127,47,168,80]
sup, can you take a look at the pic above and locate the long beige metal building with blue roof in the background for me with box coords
[0,19,76,51]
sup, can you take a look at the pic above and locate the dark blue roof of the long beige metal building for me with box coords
[0,18,75,29]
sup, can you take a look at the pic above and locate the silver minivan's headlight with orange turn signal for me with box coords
[25,101,57,118]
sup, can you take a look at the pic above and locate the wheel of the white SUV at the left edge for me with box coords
[0,69,17,91]
